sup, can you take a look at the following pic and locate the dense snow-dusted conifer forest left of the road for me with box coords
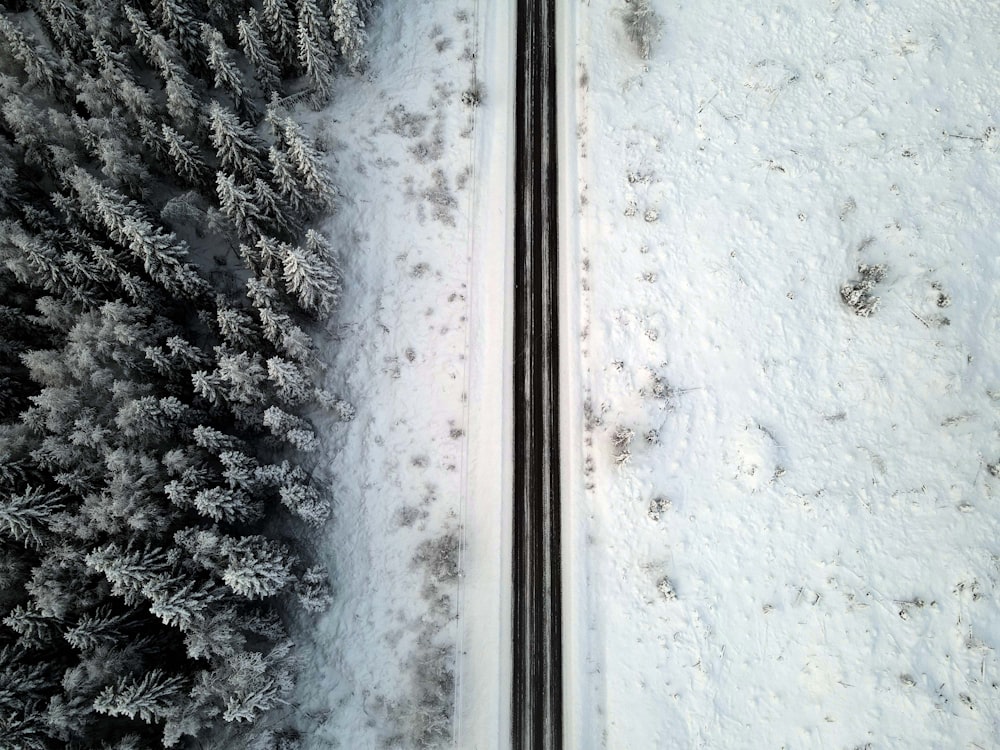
[0,0,370,750]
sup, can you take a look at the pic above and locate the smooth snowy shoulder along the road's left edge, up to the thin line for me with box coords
[455,0,515,750]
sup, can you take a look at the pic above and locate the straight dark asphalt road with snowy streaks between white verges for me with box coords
[511,0,562,750]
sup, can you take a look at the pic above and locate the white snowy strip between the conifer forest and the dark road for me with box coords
[286,0,511,750]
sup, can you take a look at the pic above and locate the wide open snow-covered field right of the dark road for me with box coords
[561,0,1000,748]
